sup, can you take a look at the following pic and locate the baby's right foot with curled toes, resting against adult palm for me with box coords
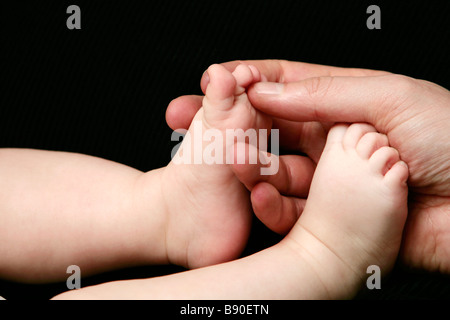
[287,124,408,298]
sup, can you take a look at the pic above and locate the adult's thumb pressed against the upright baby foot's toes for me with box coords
[248,75,413,130]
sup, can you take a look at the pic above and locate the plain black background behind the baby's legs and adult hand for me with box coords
[0,0,450,299]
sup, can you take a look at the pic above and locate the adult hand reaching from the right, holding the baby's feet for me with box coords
[167,60,450,273]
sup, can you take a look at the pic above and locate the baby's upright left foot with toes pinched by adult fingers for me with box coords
[162,64,271,268]
